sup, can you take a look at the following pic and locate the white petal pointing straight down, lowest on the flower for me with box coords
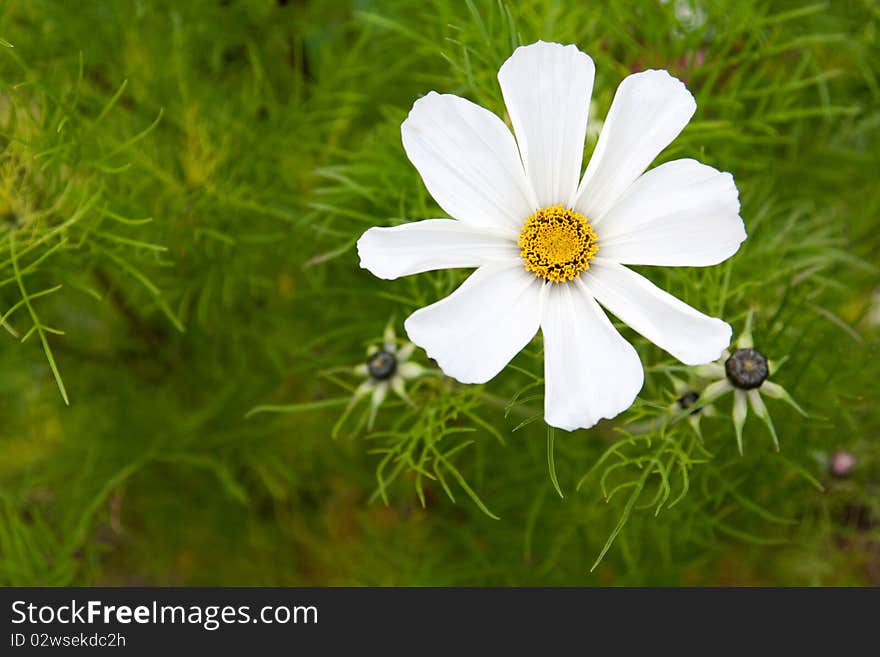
[541,282,644,431]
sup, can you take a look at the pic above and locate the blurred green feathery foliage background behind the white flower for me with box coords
[0,0,880,585]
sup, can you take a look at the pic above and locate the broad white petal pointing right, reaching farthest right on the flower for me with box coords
[596,160,746,267]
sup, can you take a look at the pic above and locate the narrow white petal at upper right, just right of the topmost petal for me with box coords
[574,71,697,222]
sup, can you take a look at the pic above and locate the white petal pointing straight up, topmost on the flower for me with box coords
[498,41,596,207]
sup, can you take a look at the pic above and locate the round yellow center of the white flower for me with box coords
[517,205,599,283]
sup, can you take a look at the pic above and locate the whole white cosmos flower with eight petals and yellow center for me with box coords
[358,41,746,430]
